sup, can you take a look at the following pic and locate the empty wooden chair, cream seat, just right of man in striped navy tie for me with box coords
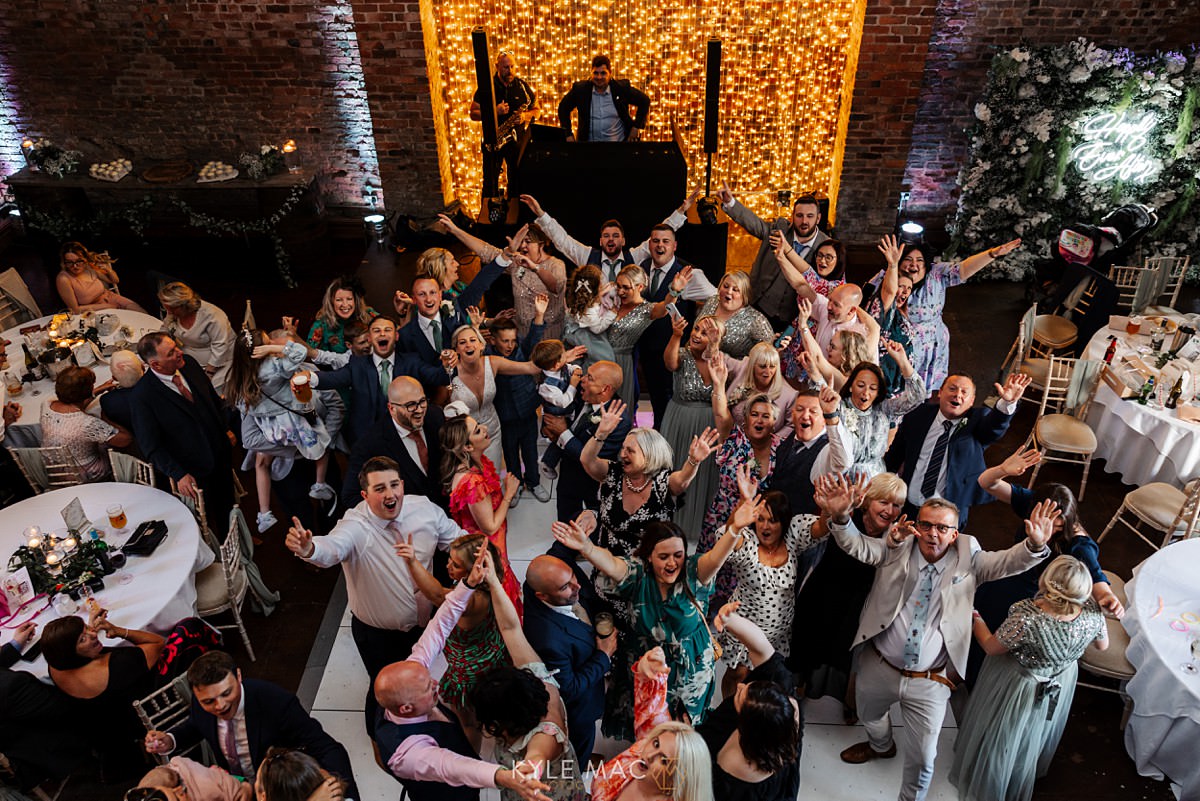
[1026,356,1104,500]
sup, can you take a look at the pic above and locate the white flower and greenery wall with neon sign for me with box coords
[948,38,1200,279]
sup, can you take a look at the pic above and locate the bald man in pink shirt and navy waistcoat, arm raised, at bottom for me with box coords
[372,556,550,801]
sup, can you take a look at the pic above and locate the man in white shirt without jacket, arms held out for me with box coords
[287,457,467,731]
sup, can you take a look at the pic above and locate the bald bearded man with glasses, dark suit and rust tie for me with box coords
[342,375,449,511]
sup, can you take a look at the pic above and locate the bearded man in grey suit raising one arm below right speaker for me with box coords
[719,186,829,331]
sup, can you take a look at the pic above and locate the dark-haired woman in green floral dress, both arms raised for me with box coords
[551,522,734,740]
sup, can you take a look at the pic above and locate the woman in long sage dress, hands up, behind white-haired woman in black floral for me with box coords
[662,317,725,542]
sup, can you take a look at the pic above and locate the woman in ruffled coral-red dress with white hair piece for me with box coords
[440,403,524,619]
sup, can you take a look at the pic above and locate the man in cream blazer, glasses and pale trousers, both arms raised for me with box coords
[815,474,1057,801]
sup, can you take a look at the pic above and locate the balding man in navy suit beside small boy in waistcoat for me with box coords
[541,361,630,522]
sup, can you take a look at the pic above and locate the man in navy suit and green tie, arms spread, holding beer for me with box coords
[312,314,457,448]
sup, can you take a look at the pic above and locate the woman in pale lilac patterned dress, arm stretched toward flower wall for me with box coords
[870,239,1021,392]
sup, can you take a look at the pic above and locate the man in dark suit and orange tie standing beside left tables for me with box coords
[133,331,234,530]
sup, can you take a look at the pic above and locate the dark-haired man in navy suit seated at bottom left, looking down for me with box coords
[145,651,359,799]
